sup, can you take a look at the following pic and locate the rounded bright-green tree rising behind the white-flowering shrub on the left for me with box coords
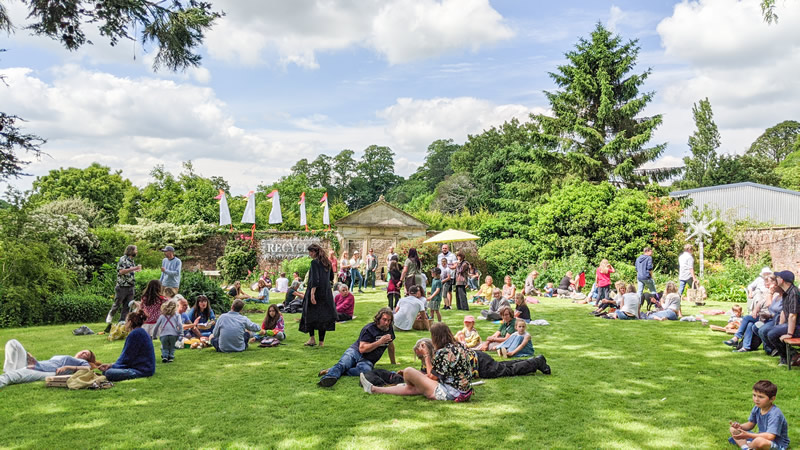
[31,163,131,224]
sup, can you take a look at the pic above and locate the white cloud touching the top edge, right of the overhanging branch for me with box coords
[205,0,513,69]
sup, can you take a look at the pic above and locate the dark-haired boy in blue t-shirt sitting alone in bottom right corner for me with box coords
[728,380,789,449]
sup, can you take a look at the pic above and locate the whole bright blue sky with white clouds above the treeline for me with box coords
[0,0,800,193]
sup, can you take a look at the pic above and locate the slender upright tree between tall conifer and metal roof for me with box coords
[681,98,720,188]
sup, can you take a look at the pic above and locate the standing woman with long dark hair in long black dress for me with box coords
[300,244,336,347]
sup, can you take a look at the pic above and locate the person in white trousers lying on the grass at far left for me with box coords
[0,339,100,388]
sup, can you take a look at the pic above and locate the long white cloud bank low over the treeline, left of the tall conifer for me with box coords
[0,65,541,192]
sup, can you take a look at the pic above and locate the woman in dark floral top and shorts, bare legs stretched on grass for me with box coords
[361,322,473,402]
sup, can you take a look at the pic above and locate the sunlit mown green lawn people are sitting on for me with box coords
[0,292,800,448]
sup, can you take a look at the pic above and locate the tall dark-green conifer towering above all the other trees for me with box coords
[533,23,674,187]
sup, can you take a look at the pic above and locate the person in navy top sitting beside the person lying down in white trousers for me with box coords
[98,312,158,381]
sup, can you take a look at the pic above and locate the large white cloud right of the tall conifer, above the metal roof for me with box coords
[649,0,800,155]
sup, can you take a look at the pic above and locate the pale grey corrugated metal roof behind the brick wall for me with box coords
[669,182,800,226]
